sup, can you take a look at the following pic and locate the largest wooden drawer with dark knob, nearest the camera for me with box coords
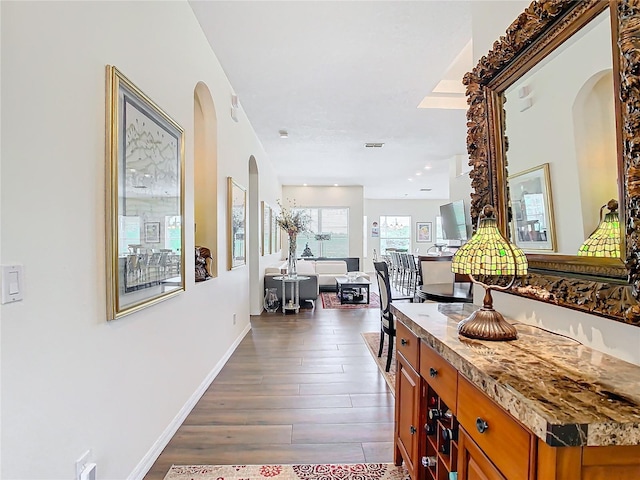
[457,376,533,480]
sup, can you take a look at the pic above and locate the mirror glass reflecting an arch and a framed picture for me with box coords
[504,10,618,255]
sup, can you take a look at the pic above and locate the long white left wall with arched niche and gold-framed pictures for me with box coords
[0,2,279,480]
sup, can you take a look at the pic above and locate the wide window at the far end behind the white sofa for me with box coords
[296,207,349,258]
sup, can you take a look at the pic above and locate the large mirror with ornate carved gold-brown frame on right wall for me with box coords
[464,0,640,326]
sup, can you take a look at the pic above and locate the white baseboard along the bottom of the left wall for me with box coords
[127,324,251,480]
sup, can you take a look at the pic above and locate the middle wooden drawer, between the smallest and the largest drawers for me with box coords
[420,342,458,415]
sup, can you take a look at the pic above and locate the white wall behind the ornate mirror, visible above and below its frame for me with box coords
[472,1,640,365]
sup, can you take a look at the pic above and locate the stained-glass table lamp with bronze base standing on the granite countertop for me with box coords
[451,205,528,341]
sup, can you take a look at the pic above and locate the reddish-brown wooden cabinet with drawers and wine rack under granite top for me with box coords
[394,321,640,480]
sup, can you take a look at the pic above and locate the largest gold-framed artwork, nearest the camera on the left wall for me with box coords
[106,65,185,320]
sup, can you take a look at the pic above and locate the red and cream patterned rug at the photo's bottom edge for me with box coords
[164,463,411,480]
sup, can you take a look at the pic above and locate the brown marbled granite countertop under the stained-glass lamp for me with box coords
[391,303,640,446]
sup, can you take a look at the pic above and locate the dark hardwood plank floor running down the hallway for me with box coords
[145,292,394,480]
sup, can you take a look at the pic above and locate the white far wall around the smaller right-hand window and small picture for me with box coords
[364,199,449,272]
